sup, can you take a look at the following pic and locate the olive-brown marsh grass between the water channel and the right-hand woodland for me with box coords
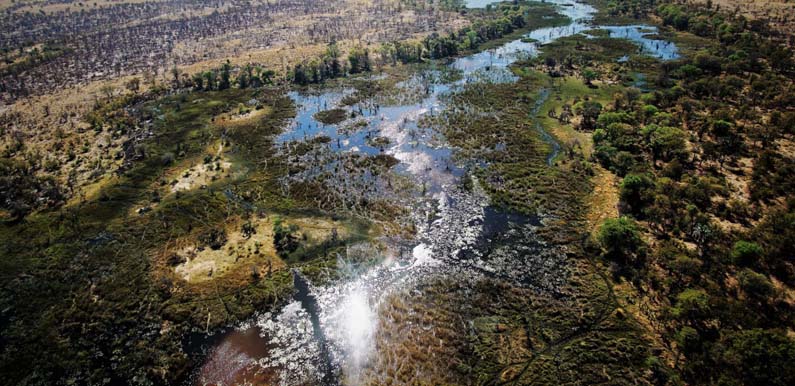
[410,15,669,384]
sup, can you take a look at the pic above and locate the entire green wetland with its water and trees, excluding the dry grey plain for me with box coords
[0,0,795,386]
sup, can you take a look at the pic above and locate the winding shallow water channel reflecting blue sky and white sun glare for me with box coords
[194,0,677,385]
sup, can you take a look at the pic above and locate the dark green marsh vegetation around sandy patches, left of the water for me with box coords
[0,83,366,384]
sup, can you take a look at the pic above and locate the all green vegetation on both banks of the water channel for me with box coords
[0,0,795,385]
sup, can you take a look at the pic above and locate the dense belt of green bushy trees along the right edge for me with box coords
[575,5,795,385]
